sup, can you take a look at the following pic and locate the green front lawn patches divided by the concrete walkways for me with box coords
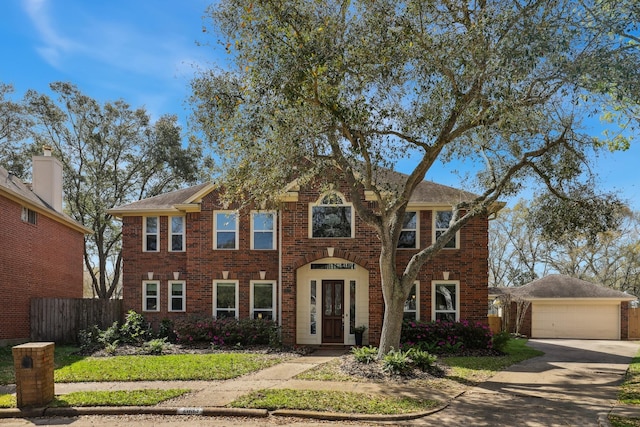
[0,340,542,414]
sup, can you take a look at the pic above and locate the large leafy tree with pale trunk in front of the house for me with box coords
[191,0,640,354]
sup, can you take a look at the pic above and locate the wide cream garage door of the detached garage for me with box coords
[531,301,620,340]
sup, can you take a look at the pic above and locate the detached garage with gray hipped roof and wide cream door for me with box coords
[511,274,636,340]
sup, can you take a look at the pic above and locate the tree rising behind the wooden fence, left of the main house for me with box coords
[0,82,203,298]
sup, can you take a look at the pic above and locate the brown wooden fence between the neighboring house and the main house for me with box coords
[31,298,123,343]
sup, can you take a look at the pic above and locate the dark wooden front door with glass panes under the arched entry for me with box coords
[322,280,344,344]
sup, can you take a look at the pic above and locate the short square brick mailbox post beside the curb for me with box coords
[12,342,55,408]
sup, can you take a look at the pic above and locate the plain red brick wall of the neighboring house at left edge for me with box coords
[0,197,84,340]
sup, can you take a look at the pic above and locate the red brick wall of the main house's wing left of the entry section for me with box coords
[122,193,278,327]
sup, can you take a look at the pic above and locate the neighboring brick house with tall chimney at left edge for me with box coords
[0,150,90,345]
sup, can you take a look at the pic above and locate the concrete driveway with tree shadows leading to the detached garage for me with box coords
[396,339,640,426]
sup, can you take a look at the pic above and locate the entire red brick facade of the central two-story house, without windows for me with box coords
[123,184,488,344]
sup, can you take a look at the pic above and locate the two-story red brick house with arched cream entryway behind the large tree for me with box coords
[110,172,488,345]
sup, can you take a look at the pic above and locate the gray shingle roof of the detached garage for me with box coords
[511,274,635,301]
